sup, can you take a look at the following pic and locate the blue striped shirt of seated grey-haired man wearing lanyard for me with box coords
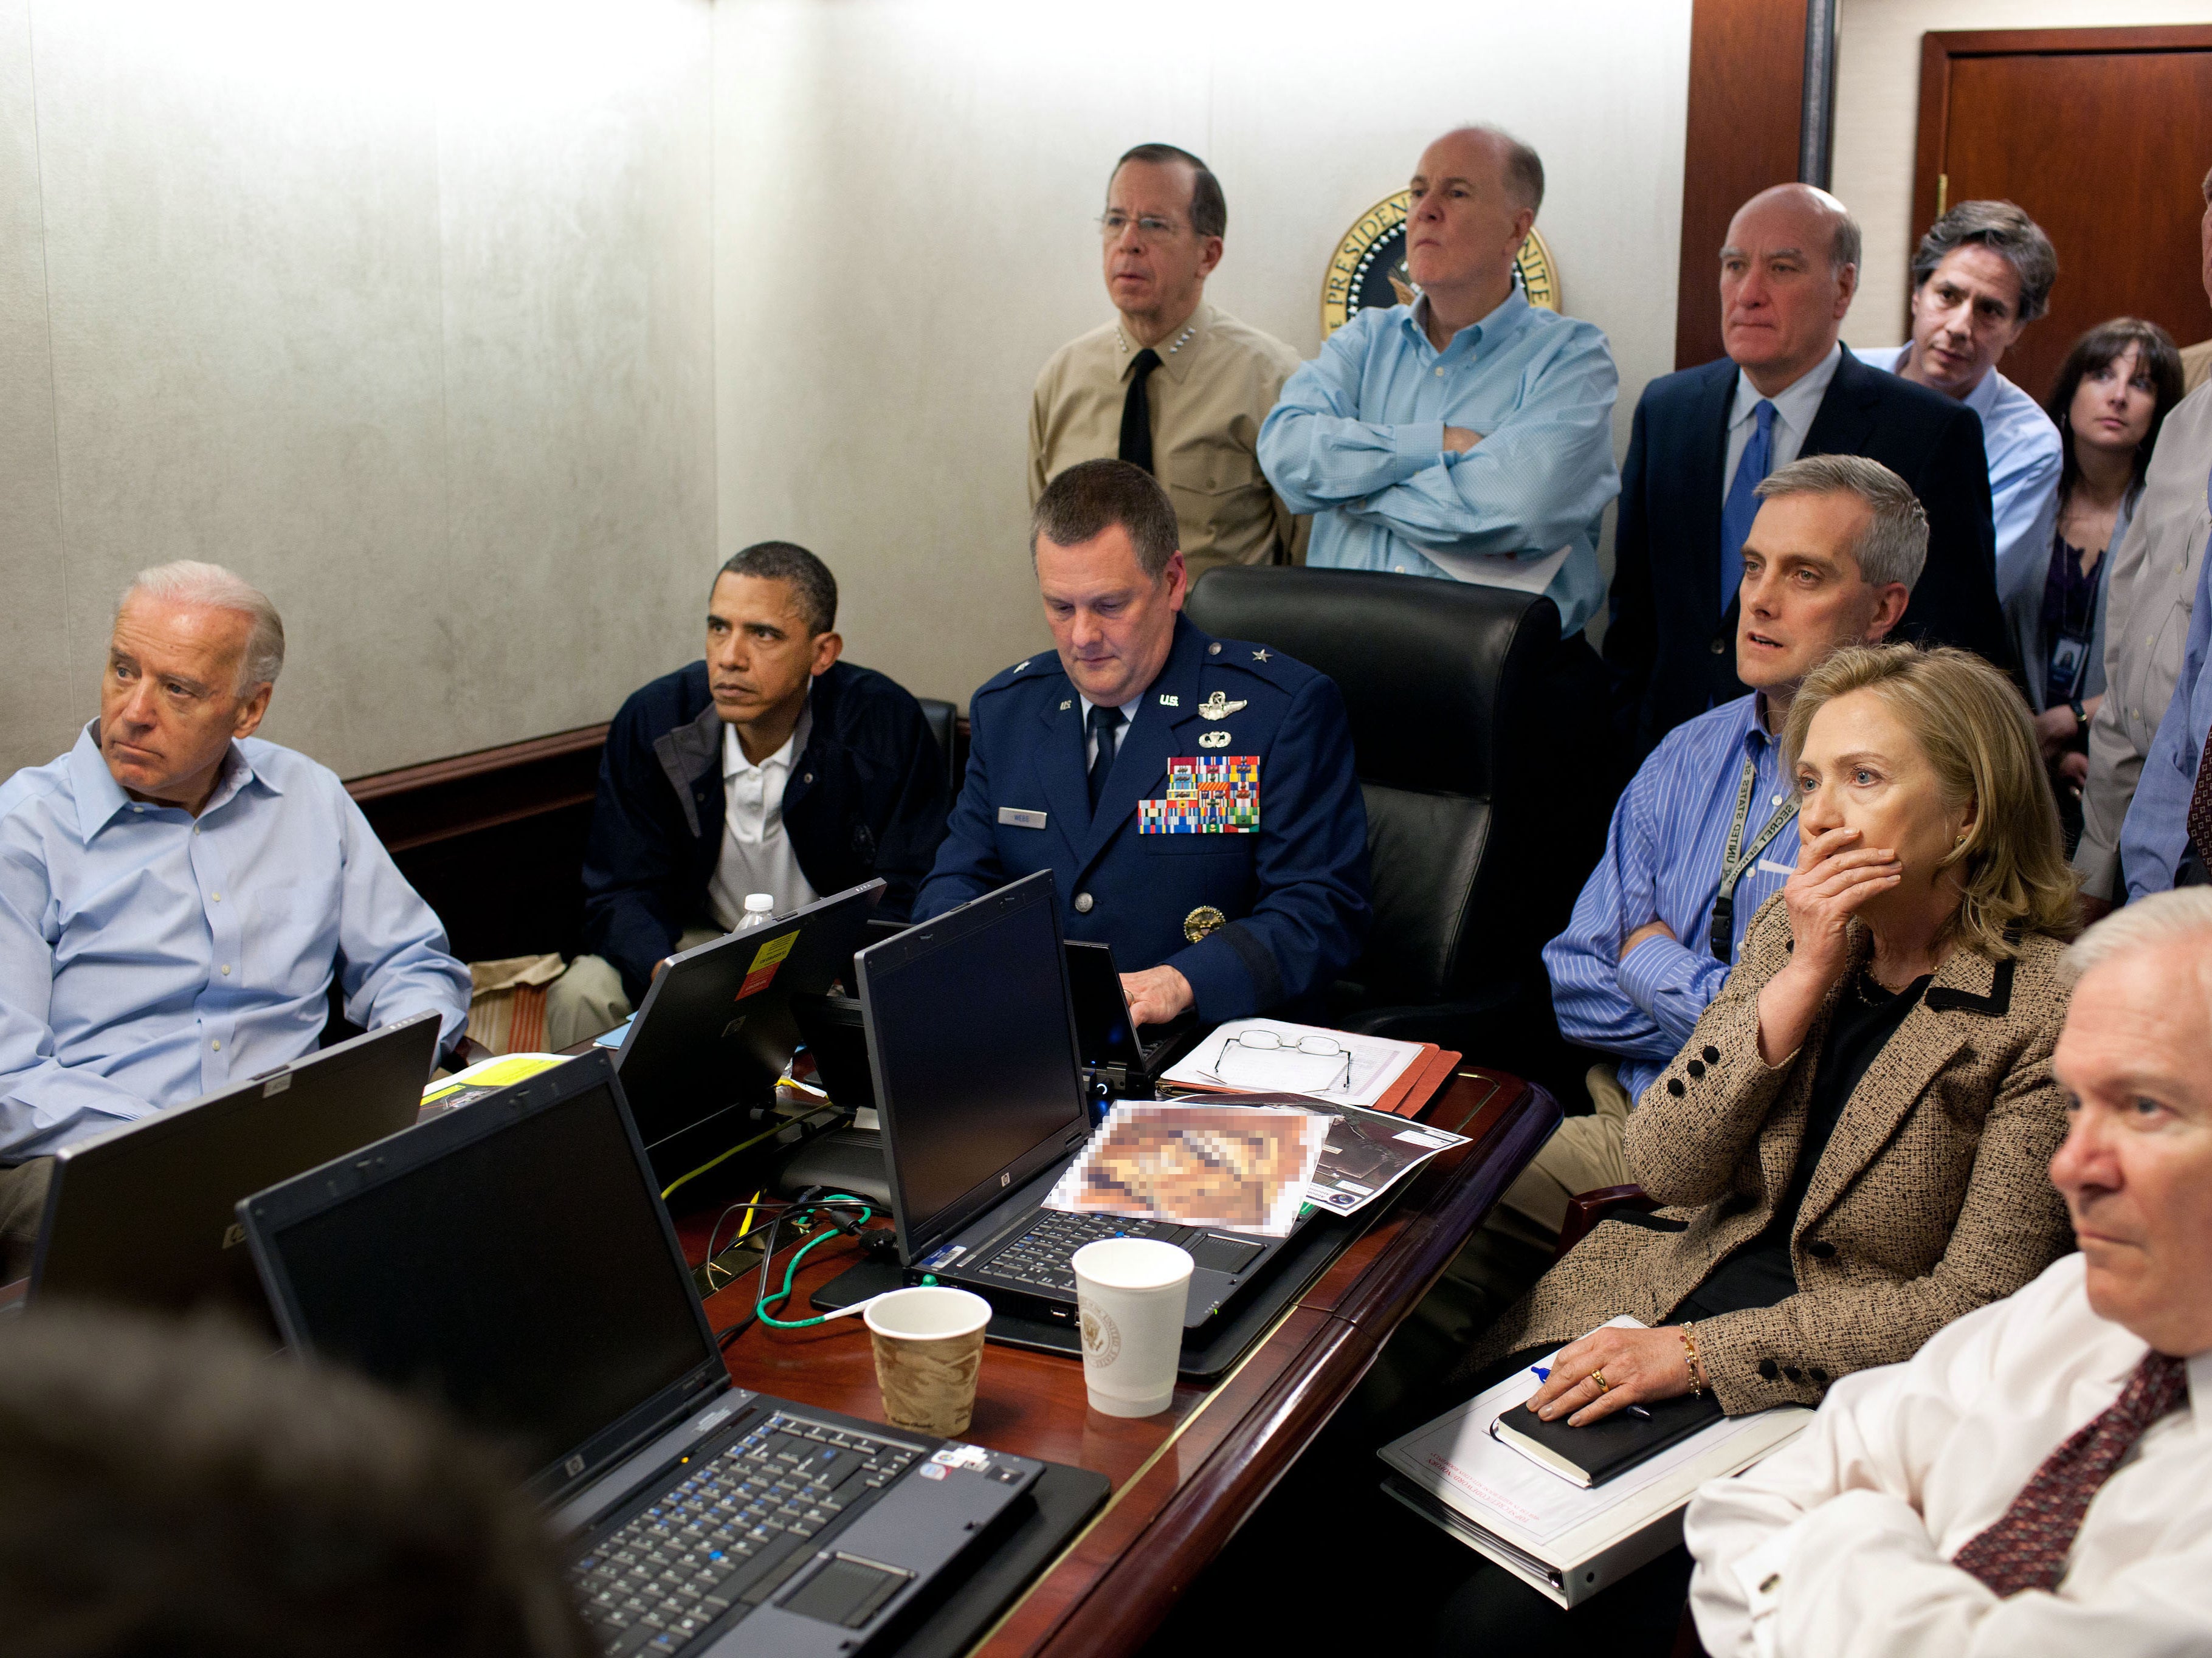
[1544,692,1799,1099]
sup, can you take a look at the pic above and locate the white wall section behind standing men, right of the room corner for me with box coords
[714,0,1690,703]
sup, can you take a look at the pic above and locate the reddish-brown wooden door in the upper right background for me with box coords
[1907,24,2212,400]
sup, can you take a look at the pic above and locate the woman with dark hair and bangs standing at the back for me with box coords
[2004,316,2181,853]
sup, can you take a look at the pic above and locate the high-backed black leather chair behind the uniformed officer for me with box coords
[1188,568,1602,1081]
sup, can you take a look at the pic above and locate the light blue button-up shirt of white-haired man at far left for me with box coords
[0,721,469,1163]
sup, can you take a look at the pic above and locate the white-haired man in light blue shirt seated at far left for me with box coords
[0,562,469,1273]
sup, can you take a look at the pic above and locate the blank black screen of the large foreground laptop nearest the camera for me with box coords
[239,1052,728,1495]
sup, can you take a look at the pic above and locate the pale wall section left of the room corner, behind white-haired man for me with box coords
[0,0,714,776]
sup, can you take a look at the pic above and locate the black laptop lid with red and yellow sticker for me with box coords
[615,880,883,1145]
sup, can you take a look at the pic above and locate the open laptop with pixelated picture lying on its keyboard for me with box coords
[861,869,1283,1329]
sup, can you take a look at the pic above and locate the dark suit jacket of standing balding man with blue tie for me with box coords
[1606,347,2013,763]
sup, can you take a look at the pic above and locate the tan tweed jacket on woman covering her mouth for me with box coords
[1462,895,2070,1415]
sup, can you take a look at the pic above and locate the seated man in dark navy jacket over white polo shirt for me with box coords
[546,542,946,1048]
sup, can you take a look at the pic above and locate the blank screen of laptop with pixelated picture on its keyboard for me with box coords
[861,869,1088,1265]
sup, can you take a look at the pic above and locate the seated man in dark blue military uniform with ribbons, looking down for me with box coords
[914,460,1370,1023]
